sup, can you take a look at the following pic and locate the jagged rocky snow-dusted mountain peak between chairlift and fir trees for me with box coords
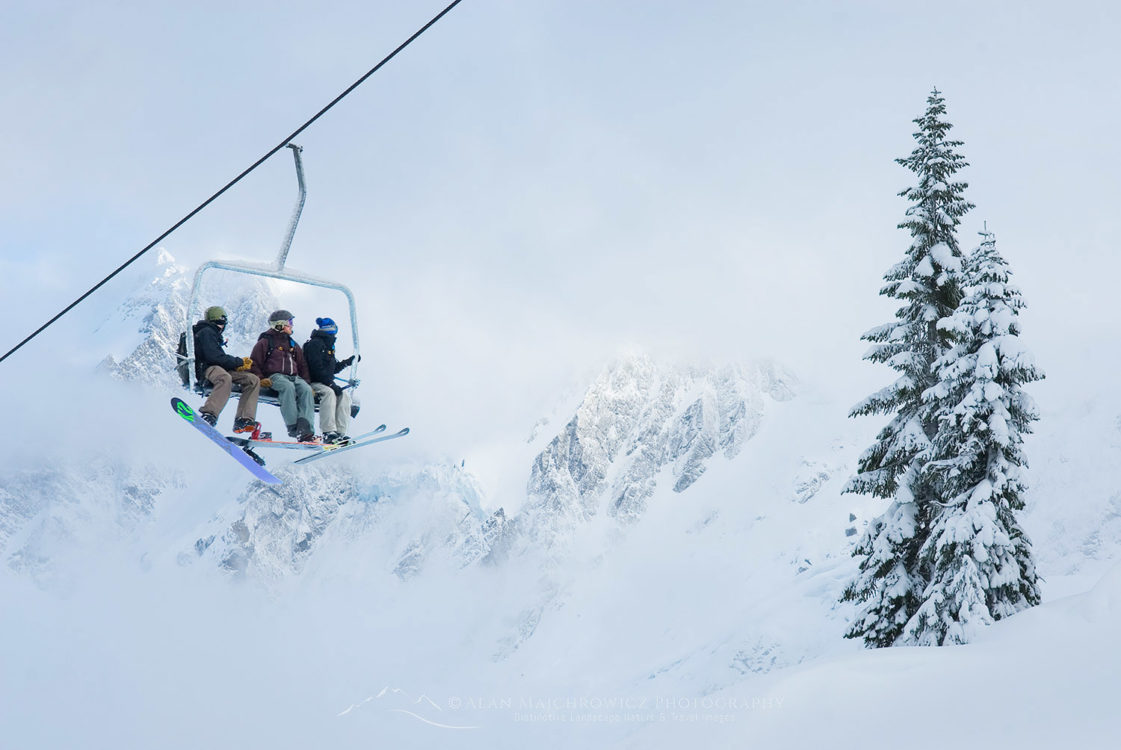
[525,355,796,546]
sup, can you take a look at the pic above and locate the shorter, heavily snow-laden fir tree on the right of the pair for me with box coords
[901,233,1044,646]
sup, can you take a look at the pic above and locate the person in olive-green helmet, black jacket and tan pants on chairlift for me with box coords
[192,307,261,433]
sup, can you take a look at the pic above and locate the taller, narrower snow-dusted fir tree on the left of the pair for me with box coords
[842,89,973,647]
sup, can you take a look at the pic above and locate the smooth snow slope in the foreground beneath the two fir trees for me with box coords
[629,566,1121,749]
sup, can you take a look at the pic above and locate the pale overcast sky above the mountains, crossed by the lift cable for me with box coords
[0,0,1121,450]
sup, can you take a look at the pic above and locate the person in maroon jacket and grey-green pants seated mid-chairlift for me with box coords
[249,309,315,443]
